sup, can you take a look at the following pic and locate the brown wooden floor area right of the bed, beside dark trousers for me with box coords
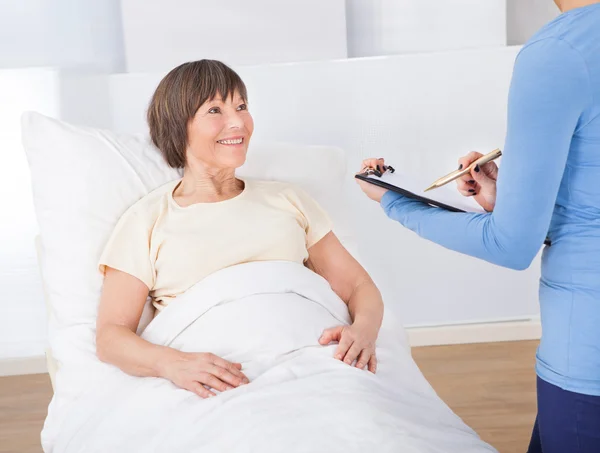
[413,341,538,453]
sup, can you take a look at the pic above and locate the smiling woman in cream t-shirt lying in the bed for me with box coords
[96,60,383,397]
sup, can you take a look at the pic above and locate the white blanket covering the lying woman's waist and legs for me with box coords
[43,262,496,453]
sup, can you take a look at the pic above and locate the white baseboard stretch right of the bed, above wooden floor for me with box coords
[406,319,542,347]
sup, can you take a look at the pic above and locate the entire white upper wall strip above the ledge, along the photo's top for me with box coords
[0,0,559,72]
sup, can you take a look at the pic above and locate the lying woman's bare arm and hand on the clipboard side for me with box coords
[306,232,383,372]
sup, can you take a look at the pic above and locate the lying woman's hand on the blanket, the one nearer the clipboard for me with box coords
[319,322,379,373]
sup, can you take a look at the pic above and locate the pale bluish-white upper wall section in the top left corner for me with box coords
[0,0,123,72]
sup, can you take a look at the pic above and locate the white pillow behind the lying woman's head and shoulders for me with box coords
[22,112,357,384]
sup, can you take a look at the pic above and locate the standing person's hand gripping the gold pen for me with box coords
[456,151,498,212]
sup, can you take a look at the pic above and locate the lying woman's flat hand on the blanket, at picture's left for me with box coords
[160,348,250,398]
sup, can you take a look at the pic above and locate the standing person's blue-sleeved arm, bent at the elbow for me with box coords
[381,39,591,269]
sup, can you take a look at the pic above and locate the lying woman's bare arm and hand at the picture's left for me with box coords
[96,267,248,397]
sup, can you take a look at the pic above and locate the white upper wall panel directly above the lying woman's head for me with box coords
[121,0,347,72]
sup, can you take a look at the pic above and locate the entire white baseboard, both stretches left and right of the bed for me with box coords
[0,319,542,376]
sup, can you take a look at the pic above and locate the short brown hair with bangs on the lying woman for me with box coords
[148,60,248,168]
